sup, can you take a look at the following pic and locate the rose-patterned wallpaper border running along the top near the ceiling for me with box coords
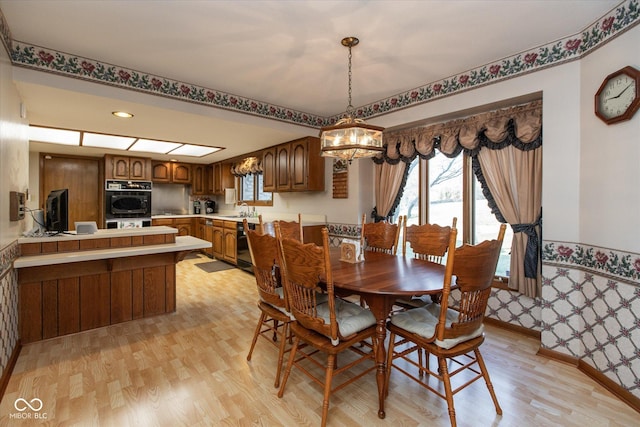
[0,0,640,128]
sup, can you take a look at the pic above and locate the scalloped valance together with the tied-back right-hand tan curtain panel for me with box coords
[374,100,542,298]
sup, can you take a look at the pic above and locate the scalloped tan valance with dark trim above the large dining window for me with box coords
[373,100,542,164]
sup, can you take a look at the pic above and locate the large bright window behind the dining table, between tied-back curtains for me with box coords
[394,150,513,277]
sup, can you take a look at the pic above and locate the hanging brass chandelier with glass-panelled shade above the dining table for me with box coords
[320,37,384,163]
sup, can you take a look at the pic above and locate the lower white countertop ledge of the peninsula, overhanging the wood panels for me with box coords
[13,236,211,268]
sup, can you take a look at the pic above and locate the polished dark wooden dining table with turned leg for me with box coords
[331,248,453,418]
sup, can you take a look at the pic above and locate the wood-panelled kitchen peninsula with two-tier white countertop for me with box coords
[13,226,211,344]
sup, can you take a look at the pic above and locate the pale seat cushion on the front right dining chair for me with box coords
[391,303,484,349]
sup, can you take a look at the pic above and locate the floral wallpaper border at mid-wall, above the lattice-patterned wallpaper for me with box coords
[542,241,640,287]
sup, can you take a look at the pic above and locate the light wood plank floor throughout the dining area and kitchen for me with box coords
[0,258,640,427]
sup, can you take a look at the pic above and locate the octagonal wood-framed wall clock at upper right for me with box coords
[595,66,640,125]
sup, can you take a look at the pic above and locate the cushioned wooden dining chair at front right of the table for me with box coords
[385,224,506,427]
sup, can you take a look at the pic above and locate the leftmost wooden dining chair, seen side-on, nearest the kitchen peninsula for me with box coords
[243,219,291,387]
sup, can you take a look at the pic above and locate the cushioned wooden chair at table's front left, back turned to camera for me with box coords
[276,223,378,426]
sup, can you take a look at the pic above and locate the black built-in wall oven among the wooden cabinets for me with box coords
[105,180,152,228]
